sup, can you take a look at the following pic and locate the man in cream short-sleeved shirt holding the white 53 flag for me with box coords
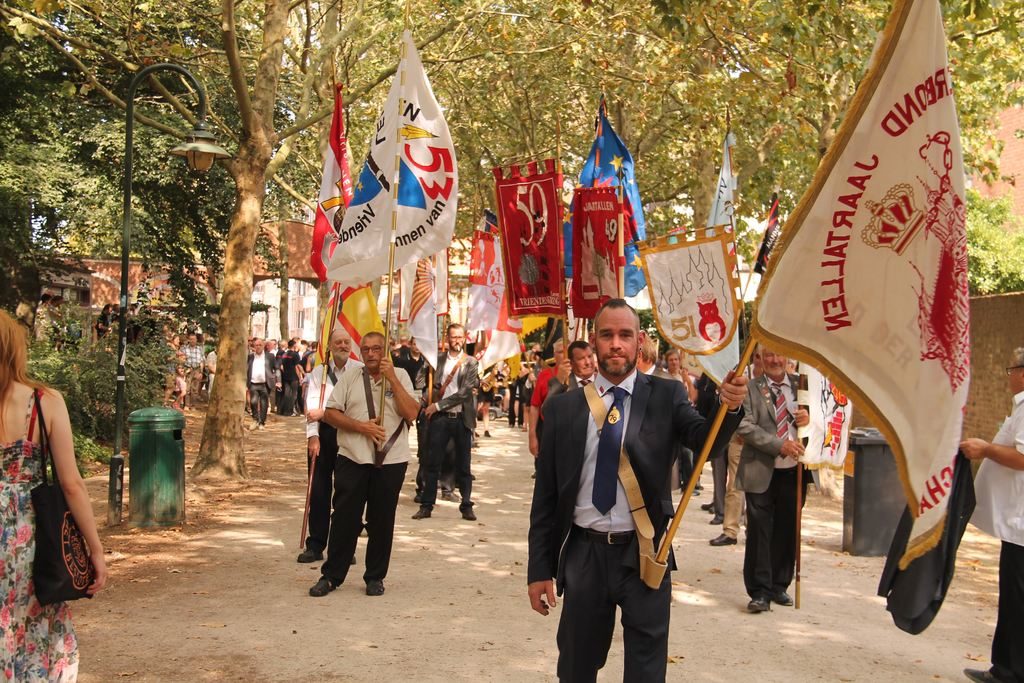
[309,332,420,598]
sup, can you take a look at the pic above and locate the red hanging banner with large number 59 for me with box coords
[494,159,565,316]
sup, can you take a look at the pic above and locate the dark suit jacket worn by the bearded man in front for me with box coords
[526,372,742,591]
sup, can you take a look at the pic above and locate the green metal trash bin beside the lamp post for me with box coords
[128,408,185,526]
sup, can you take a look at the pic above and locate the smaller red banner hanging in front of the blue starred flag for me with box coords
[569,187,623,318]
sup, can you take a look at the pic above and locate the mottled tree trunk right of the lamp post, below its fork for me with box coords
[191,152,269,477]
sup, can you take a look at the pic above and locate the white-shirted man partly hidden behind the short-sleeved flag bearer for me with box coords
[297,327,362,563]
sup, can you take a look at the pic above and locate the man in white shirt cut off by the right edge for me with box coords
[961,346,1024,683]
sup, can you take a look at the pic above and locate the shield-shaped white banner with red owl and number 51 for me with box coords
[639,231,740,355]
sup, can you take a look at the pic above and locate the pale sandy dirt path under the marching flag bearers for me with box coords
[73,414,998,683]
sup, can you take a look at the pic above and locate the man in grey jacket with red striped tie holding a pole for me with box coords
[736,347,810,613]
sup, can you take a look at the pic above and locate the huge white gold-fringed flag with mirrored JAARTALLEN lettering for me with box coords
[753,0,970,566]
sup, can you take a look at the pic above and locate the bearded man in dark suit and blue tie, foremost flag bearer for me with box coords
[527,299,746,683]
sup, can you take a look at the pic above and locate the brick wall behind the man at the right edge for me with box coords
[964,290,1024,439]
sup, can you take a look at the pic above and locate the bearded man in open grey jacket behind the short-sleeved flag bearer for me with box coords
[413,324,480,521]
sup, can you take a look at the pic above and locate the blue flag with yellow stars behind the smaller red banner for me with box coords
[562,98,647,296]
